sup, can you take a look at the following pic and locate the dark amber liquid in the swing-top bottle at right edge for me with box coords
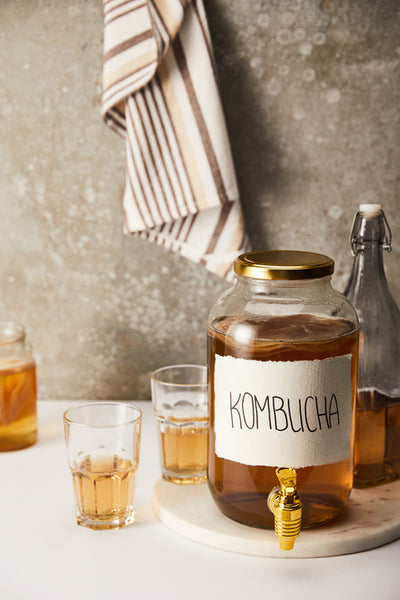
[354,389,400,488]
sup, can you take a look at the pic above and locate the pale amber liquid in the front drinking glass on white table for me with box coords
[71,455,137,529]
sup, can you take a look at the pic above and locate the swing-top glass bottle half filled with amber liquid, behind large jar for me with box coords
[344,204,400,488]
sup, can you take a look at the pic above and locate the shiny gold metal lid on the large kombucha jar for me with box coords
[234,250,335,280]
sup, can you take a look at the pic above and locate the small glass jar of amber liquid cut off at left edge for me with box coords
[0,322,37,451]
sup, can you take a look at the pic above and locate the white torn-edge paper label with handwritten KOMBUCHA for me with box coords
[214,354,352,468]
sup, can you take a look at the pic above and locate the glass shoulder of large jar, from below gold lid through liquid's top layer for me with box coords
[209,278,358,341]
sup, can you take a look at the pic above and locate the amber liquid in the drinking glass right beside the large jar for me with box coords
[160,418,208,484]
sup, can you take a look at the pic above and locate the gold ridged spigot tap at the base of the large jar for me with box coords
[267,467,302,550]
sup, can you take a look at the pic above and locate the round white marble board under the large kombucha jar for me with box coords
[153,479,400,558]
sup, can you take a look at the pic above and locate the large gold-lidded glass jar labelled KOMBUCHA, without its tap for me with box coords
[208,251,358,528]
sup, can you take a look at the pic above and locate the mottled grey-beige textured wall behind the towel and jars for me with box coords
[0,0,400,398]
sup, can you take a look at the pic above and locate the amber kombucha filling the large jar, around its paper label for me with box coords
[208,315,358,528]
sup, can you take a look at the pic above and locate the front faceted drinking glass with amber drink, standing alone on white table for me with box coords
[64,401,142,529]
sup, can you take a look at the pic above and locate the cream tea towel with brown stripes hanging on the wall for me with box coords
[102,0,248,277]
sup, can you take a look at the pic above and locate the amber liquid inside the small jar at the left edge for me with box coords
[0,361,37,451]
